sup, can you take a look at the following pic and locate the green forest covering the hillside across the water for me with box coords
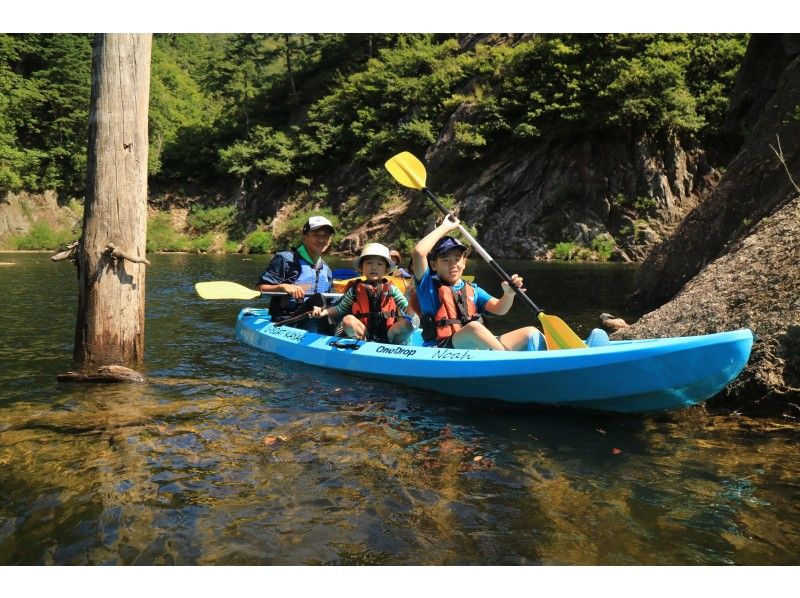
[0,34,748,252]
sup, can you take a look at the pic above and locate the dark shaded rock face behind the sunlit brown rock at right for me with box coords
[630,35,800,312]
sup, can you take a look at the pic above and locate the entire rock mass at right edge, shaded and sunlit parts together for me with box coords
[617,35,800,418]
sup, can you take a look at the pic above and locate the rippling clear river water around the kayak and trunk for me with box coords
[0,254,800,565]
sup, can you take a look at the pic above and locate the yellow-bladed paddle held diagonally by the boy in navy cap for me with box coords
[385,152,586,349]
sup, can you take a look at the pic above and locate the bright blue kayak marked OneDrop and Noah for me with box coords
[236,308,753,413]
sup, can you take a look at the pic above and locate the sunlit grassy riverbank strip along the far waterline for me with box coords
[0,192,632,262]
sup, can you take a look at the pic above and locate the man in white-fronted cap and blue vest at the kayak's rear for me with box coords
[256,216,335,334]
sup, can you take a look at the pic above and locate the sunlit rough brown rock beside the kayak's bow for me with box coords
[612,191,800,418]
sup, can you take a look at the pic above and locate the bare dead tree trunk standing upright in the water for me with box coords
[59,34,152,381]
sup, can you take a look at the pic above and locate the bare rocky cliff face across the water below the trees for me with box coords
[425,131,720,259]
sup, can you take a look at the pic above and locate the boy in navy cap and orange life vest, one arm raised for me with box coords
[412,216,545,351]
